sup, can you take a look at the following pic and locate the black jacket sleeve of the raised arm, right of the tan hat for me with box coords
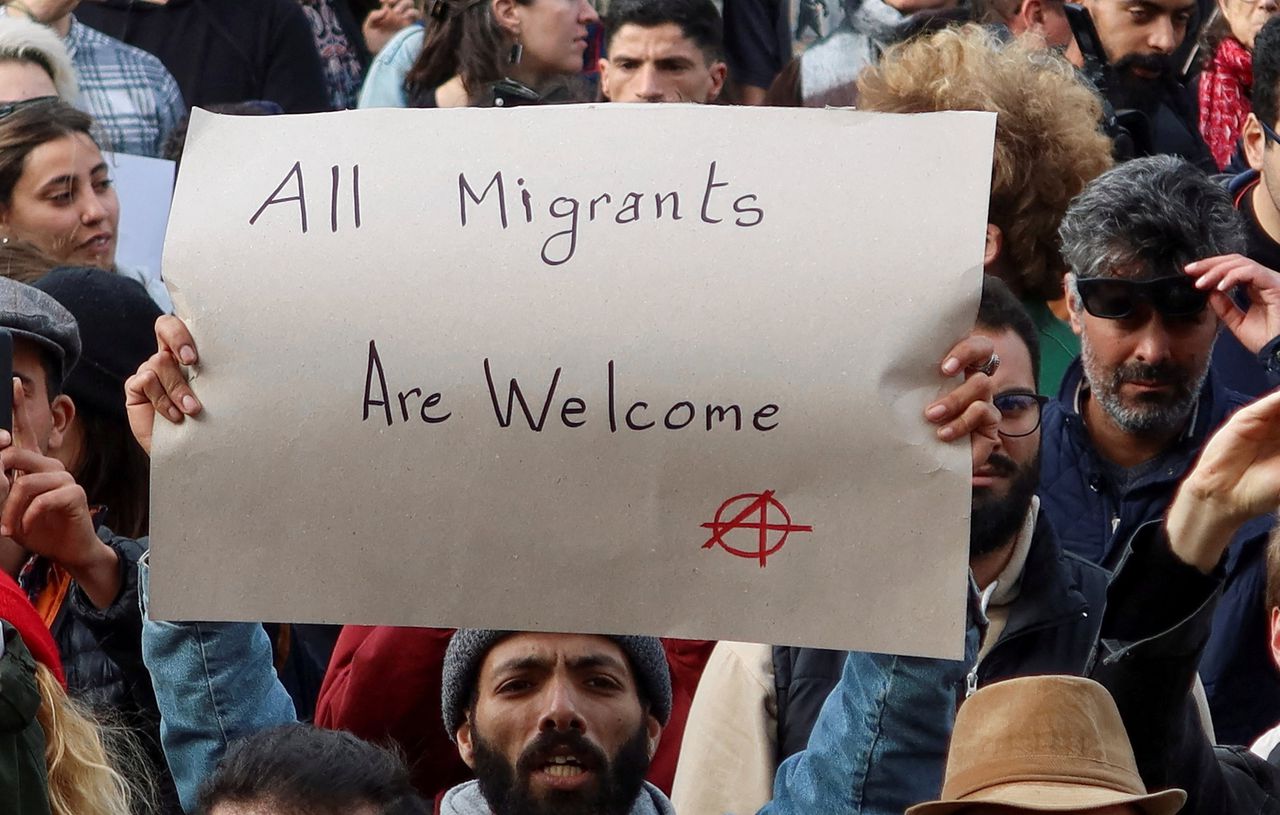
[1091,521,1280,815]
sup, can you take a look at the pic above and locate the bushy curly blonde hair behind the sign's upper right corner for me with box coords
[858,24,1111,299]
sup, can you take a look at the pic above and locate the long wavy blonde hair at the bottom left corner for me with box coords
[36,663,154,815]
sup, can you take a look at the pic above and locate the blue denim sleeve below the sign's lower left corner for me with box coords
[138,559,297,812]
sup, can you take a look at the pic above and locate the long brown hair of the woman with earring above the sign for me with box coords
[404,0,534,102]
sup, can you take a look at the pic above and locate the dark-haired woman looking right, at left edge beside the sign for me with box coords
[0,97,172,311]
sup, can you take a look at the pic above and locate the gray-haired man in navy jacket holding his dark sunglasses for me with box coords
[1039,156,1280,743]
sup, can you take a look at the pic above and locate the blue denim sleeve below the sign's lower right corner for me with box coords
[759,598,979,815]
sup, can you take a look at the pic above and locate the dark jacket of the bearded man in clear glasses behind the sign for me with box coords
[773,510,1107,764]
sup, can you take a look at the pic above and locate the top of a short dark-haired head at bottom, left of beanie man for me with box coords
[196,724,431,815]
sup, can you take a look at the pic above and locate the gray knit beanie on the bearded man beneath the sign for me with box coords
[440,628,671,741]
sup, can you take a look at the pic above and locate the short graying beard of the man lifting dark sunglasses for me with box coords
[1080,336,1212,436]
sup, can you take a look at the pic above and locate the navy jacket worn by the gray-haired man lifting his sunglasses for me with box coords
[1039,360,1280,745]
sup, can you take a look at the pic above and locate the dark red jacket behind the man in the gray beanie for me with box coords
[316,626,716,800]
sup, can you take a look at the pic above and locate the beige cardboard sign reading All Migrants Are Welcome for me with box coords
[151,105,995,658]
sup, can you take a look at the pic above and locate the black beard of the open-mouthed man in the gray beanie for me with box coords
[474,723,649,815]
